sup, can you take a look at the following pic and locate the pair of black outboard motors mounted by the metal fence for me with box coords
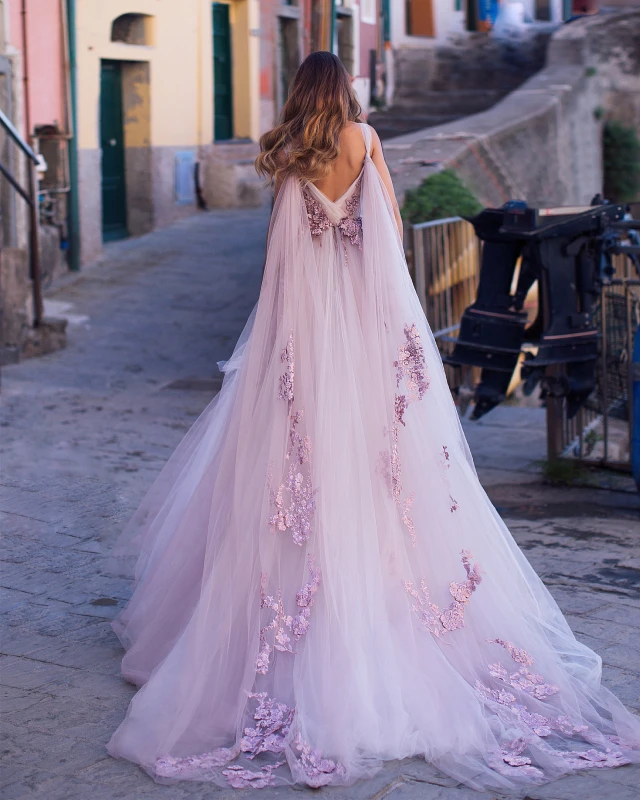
[444,198,640,419]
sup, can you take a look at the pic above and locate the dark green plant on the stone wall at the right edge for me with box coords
[602,120,640,203]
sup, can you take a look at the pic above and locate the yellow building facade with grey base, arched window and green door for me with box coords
[75,0,218,263]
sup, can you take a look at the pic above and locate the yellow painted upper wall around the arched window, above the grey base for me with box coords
[76,0,213,149]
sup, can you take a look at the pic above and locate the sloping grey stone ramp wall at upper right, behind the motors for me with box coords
[384,9,640,211]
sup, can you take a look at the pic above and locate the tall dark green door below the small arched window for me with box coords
[100,61,128,242]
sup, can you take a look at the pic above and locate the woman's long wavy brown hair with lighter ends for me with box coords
[255,51,362,181]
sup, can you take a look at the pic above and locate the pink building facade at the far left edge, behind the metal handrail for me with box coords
[0,0,70,365]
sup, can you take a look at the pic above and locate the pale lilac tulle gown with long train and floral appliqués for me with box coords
[108,125,640,794]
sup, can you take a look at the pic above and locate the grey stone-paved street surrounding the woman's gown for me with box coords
[0,209,640,800]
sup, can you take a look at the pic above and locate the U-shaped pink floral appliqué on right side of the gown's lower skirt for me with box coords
[404,550,482,637]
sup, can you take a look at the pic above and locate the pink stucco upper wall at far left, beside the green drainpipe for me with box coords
[9,0,66,133]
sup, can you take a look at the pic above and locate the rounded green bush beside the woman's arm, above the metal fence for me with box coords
[402,169,482,223]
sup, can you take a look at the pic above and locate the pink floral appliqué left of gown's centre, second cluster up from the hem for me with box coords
[256,554,322,675]
